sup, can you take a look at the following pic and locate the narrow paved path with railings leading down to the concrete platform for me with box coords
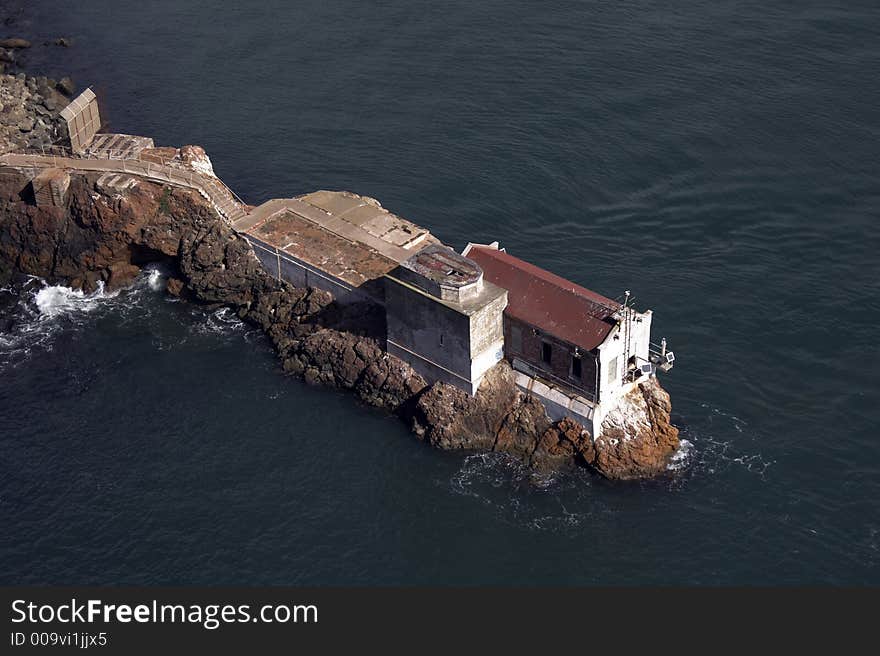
[0,153,246,224]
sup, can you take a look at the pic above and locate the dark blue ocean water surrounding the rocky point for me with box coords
[0,0,880,584]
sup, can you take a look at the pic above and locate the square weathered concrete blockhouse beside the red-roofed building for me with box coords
[385,245,507,394]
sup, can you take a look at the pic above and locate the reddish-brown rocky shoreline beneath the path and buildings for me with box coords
[0,57,679,479]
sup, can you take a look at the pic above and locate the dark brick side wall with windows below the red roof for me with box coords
[504,315,598,401]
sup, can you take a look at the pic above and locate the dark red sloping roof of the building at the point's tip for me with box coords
[467,245,620,351]
